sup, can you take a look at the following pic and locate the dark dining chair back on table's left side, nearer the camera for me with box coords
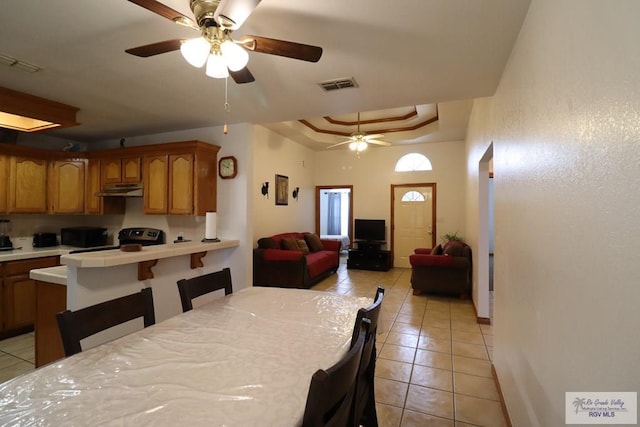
[56,288,156,356]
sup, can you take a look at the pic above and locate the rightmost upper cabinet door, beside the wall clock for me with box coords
[168,154,194,215]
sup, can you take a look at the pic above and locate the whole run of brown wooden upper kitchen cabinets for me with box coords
[0,141,220,216]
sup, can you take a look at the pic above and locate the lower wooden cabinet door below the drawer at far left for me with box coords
[2,274,36,330]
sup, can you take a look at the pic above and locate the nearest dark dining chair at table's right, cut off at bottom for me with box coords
[302,319,373,427]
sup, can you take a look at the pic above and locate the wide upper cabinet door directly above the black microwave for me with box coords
[49,160,85,214]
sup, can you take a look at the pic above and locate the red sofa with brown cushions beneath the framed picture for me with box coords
[253,232,342,288]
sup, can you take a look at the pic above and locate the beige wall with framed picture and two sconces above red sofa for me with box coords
[249,126,315,244]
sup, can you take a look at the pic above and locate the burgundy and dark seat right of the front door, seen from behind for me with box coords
[409,241,473,299]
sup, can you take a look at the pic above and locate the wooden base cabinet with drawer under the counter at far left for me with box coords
[0,256,60,336]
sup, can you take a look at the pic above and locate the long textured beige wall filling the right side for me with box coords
[467,0,640,426]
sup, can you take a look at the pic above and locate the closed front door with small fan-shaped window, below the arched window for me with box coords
[393,186,433,268]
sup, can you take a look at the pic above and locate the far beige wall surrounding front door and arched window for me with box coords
[314,141,465,246]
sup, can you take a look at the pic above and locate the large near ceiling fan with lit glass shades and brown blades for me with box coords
[125,0,322,83]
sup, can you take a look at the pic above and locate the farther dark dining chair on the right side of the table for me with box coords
[351,287,384,427]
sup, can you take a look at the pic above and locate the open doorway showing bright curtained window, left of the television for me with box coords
[316,185,353,251]
